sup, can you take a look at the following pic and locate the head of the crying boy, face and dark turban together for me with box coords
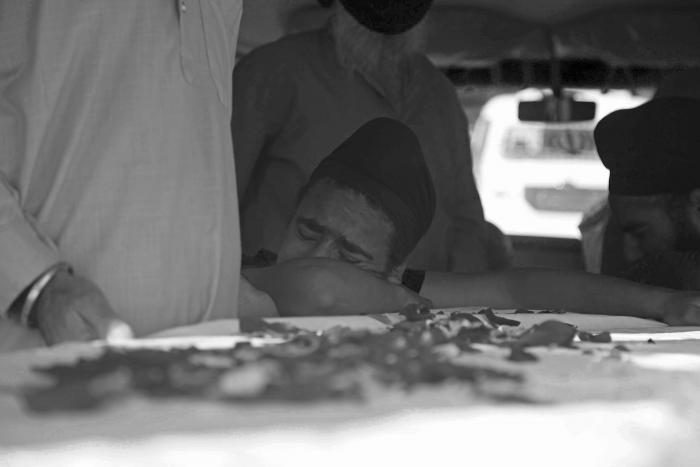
[279,118,435,277]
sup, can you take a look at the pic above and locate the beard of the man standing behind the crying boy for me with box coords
[331,7,424,98]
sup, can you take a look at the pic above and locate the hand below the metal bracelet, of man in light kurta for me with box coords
[33,271,132,345]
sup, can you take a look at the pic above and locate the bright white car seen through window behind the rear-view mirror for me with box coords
[472,89,646,238]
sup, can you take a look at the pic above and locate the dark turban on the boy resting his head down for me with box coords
[309,118,435,261]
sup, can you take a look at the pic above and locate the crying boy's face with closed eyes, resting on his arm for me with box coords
[279,180,393,277]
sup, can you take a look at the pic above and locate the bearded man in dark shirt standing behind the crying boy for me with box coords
[232,0,504,272]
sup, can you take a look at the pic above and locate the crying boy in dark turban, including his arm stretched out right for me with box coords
[243,118,700,324]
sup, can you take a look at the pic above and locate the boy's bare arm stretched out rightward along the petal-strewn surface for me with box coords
[421,269,700,324]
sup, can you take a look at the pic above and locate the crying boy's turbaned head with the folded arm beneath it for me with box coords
[243,118,435,315]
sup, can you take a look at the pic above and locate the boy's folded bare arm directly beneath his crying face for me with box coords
[243,258,430,316]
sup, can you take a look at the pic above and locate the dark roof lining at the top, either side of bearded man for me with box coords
[240,0,700,68]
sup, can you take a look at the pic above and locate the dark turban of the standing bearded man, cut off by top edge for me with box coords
[340,0,433,34]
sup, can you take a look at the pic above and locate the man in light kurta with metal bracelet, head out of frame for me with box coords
[0,0,247,342]
